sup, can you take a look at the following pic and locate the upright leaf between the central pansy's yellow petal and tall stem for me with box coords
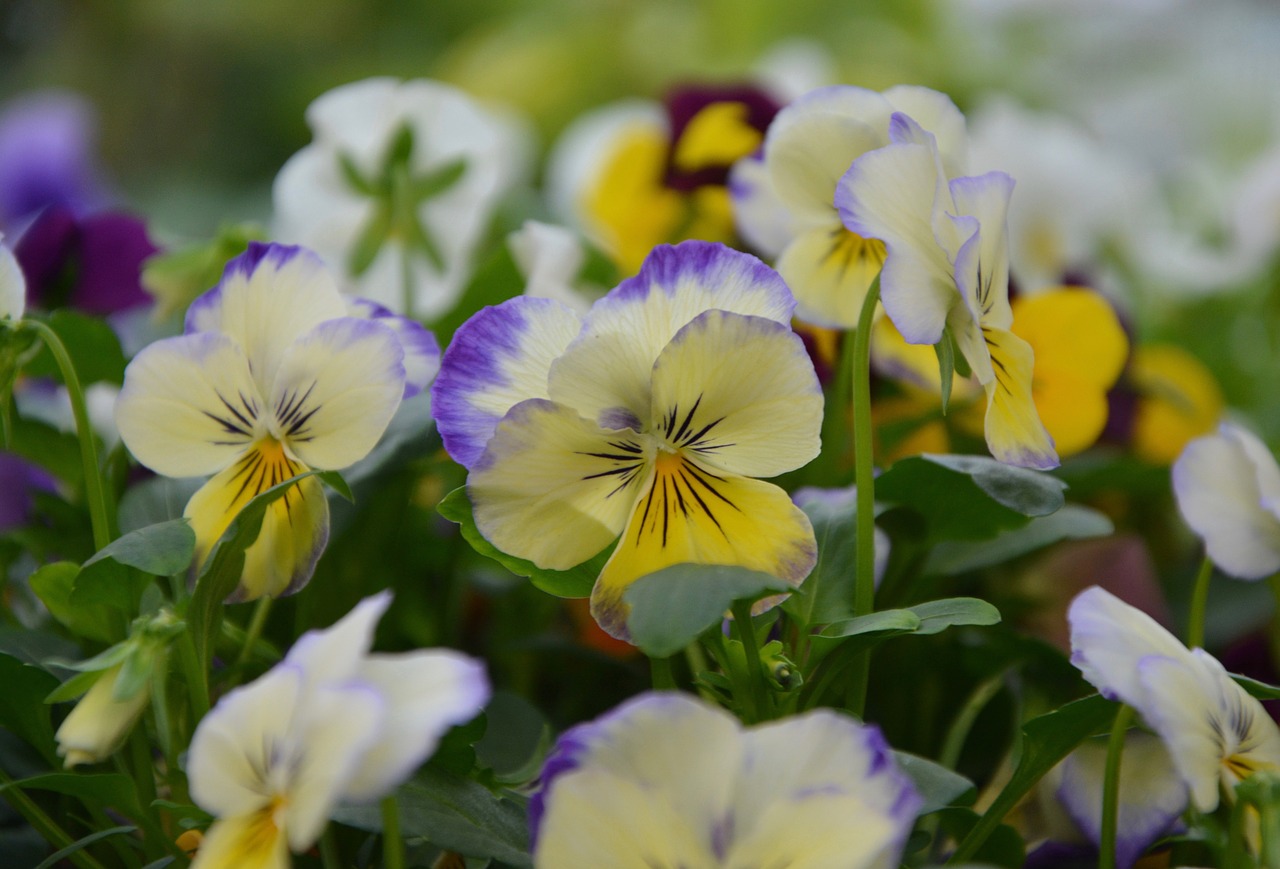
[782,489,858,627]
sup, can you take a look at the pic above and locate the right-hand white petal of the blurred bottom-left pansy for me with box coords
[343,650,489,801]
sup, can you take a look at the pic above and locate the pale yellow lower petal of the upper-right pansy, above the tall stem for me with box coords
[778,223,884,329]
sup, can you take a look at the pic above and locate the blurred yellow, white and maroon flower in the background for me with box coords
[548,84,778,275]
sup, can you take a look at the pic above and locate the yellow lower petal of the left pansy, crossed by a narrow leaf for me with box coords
[183,438,329,600]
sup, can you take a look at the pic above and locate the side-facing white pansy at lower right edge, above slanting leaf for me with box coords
[1068,587,1280,811]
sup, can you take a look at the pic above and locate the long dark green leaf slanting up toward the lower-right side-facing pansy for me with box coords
[951,694,1120,863]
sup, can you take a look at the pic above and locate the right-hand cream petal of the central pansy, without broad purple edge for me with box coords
[649,311,823,477]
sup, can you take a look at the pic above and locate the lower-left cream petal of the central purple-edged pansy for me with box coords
[467,399,653,570]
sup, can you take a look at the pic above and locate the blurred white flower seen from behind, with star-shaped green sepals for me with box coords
[274,78,524,319]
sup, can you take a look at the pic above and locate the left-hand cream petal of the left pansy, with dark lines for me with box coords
[115,331,266,477]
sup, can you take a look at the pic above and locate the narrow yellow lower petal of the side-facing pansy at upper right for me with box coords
[982,329,1057,470]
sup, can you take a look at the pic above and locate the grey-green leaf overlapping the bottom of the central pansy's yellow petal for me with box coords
[622,564,792,658]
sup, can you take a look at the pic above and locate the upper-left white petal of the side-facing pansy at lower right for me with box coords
[1066,586,1190,710]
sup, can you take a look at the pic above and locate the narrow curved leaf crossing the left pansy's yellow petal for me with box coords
[187,471,319,675]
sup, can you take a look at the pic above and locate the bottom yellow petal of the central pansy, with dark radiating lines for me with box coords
[591,453,818,639]
